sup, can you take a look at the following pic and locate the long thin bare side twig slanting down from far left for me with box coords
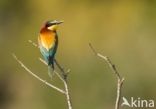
[12,54,66,94]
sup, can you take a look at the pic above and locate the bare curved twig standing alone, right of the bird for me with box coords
[89,43,124,109]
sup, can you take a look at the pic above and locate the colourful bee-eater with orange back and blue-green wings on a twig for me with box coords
[38,20,63,78]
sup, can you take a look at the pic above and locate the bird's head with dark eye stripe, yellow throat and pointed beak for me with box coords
[44,20,63,31]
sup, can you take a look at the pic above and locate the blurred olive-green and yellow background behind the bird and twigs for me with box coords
[0,0,156,109]
